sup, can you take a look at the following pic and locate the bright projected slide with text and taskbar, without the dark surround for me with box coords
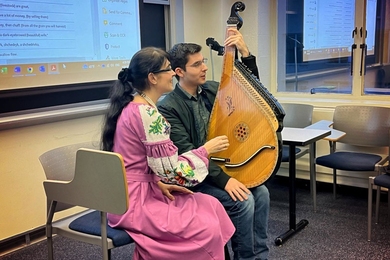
[0,0,140,91]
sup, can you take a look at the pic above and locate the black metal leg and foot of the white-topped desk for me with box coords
[275,145,309,246]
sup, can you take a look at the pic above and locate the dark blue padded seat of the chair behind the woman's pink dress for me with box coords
[69,211,134,247]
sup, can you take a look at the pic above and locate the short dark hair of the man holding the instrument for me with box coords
[168,43,202,80]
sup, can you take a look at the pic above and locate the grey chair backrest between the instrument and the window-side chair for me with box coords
[281,103,313,128]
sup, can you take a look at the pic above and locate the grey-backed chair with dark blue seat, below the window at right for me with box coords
[316,106,390,198]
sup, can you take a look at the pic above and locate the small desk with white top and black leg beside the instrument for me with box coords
[275,127,331,246]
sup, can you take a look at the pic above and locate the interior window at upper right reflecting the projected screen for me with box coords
[278,0,390,94]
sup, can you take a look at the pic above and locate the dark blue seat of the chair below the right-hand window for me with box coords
[316,152,382,171]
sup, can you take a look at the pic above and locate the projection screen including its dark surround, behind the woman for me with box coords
[0,0,169,114]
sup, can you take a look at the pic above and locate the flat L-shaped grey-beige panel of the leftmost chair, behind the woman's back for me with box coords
[43,148,128,214]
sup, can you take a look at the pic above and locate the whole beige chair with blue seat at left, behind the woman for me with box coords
[39,143,133,259]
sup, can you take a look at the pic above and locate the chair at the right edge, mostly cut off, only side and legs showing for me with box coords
[367,166,390,241]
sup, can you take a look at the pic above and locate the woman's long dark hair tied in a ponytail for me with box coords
[101,47,168,152]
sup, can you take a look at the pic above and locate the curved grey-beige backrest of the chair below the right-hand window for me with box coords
[333,106,390,147]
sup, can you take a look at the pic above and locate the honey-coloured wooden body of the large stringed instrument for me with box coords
[207,26,284,188]
